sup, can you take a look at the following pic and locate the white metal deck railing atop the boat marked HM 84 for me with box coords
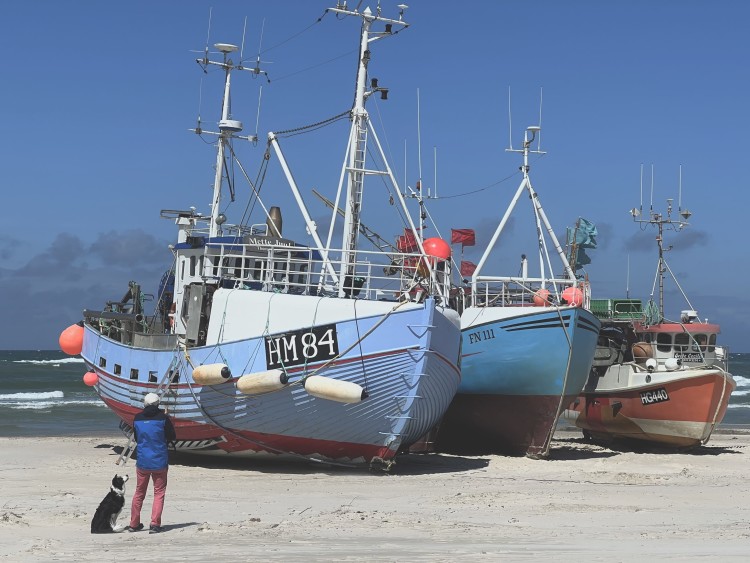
[202,241,450,301]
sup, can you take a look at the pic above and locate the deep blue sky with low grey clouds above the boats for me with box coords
[0,0,750,352]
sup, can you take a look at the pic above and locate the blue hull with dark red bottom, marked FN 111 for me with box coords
[436,307,599,456]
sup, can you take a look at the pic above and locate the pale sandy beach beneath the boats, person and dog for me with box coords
[0,432,750,562]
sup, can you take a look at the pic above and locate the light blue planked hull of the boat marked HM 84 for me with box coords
[82,291,460,465]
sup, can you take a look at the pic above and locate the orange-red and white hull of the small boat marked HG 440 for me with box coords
[565,366,735,448]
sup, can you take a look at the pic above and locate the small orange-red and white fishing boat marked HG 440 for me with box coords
[565,196,735,448]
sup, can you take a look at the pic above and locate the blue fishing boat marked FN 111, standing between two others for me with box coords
[435,127,600,457]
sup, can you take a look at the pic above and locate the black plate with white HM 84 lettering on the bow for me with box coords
[266,324,339,369]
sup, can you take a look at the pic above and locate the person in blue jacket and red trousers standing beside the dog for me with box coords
[127,393,176,534]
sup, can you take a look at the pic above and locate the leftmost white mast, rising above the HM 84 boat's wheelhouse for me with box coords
[191,43,258,237]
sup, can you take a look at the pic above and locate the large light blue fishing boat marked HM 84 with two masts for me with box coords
[61,3,460,469]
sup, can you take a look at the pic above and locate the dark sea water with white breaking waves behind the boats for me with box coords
[0,350,750,437]
